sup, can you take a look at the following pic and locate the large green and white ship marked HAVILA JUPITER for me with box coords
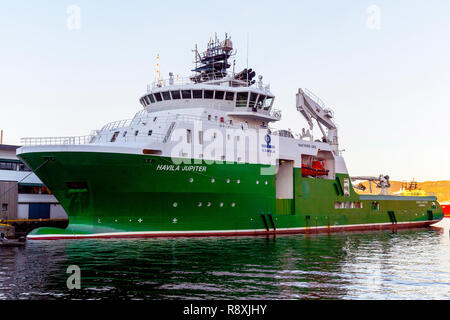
[17,35,443,240]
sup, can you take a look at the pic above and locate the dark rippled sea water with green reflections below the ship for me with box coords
[0,219,450,300]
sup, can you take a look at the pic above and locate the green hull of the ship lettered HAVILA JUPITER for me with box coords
[19,151,443,239]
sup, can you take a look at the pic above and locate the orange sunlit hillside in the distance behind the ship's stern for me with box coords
[355,180,450,202]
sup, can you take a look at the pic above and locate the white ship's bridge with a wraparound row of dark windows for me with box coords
[140,77,281,123]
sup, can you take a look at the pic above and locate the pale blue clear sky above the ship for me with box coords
[0,0,450,181]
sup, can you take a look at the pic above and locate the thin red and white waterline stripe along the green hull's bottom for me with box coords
[27,220,440,240]
